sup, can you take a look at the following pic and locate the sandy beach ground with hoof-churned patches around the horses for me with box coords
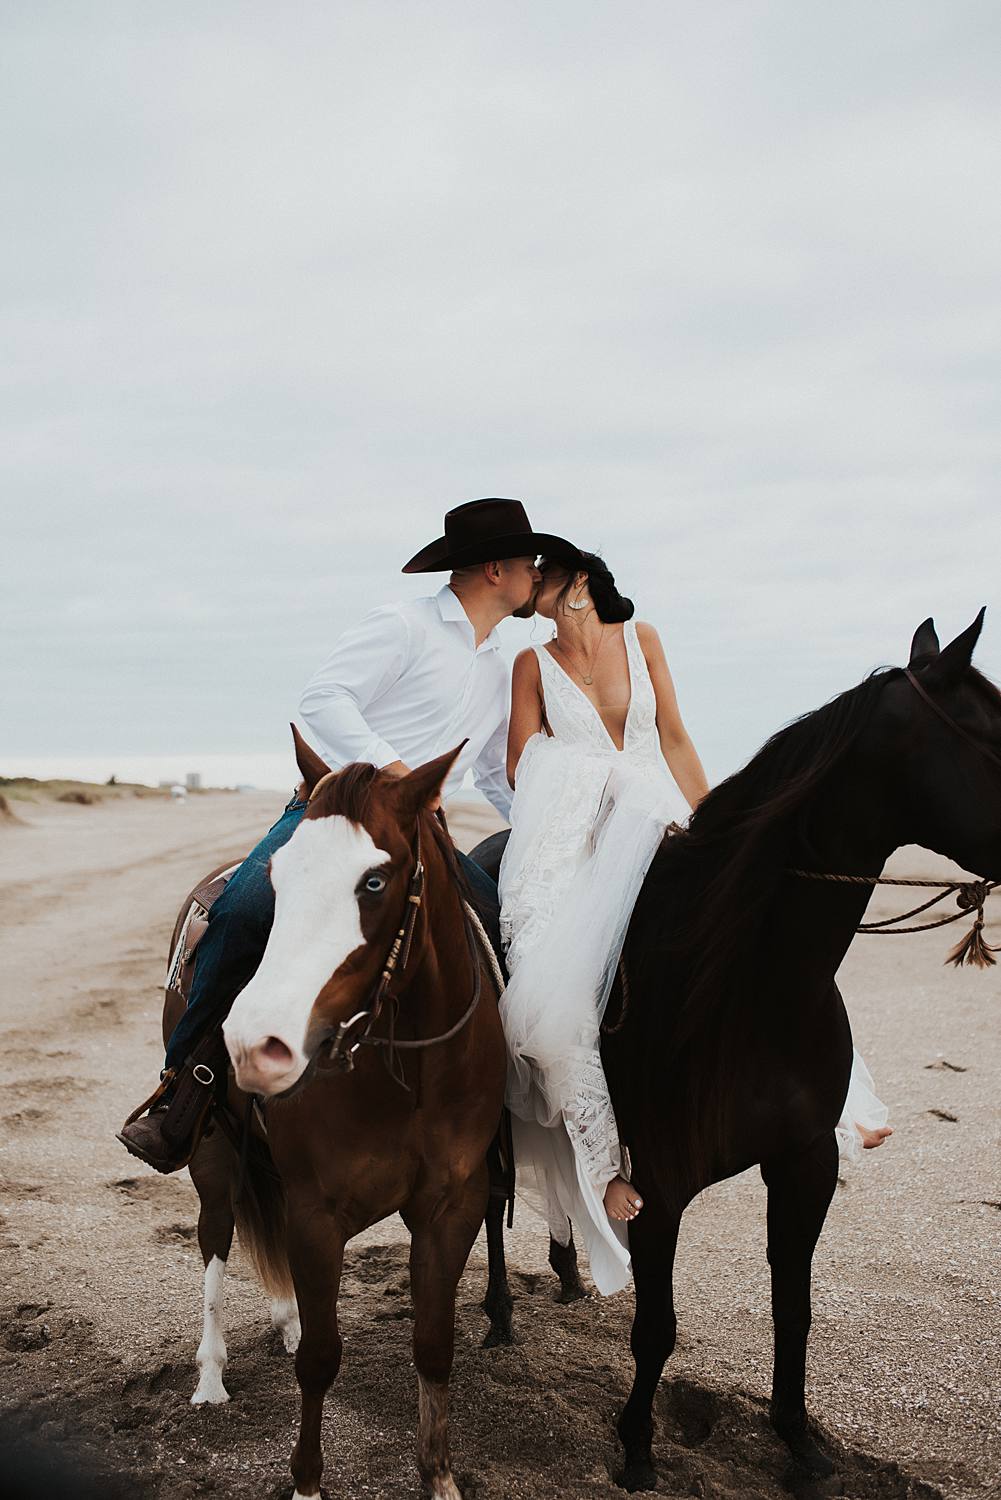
[0,794,1001,1500]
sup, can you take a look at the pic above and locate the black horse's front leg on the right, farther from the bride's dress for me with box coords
[761,1131,837,1478]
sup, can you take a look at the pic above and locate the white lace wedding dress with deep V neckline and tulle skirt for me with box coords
[500,621,885,1295]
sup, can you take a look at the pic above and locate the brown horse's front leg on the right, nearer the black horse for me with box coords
[404,1167,488,1500]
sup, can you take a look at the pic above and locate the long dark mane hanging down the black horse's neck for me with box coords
[620,668,902,1194]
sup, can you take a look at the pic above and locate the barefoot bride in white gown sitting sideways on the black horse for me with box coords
[500,552,890,1295]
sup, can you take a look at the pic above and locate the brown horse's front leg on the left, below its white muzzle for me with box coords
[288,1203,347,1500]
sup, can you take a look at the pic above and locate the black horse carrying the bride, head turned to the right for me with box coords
[473,612,1001,1493]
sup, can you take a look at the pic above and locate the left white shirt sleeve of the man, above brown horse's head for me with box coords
[299,605,410,770]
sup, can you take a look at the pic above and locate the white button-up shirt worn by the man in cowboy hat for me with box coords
[299,584,513,819]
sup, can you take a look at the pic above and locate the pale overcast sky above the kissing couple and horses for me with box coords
[0,0,1001,777]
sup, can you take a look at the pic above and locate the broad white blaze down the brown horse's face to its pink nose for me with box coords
[222,816,389,1094]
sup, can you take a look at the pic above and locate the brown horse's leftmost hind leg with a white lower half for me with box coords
[191,1133,233,1406]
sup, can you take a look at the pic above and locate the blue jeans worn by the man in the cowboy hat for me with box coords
[167,797,497,1068]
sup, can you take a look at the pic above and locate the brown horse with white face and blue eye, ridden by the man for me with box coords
[165,741,504,1500]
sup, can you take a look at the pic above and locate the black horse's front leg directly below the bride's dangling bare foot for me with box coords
[618,1193,681,1491]
